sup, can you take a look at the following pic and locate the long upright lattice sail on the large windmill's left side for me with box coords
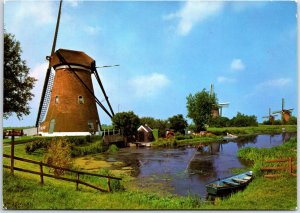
[35,0,62,127]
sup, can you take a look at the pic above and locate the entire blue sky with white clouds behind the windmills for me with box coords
[3,0,297,126]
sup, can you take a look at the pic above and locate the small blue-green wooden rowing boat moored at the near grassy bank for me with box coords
[205,171,253,195]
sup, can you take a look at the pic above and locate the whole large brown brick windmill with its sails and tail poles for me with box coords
[36,0,114,136]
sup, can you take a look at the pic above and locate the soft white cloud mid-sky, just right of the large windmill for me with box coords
[129,73,170,97]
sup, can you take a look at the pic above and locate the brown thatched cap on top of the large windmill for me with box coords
[50,49,95,70]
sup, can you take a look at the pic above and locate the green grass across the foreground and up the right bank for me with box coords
[3,127,297,210]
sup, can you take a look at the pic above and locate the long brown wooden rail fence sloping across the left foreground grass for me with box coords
[3,154,122,192]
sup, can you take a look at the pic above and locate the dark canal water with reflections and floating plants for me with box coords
[86,133,296,197]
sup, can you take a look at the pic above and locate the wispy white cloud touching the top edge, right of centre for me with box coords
[164,1,224,36]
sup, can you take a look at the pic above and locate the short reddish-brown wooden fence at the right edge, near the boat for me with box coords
[261,157,297,178]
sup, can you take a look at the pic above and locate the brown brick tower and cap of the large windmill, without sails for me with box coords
[39,49,100,136]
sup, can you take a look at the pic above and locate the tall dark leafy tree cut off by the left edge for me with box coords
[3,32,36,119]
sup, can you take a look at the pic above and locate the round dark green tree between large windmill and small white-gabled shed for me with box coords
[112,111,140,141]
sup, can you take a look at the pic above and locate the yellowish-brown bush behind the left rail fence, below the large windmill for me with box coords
[45,139,72,176]
